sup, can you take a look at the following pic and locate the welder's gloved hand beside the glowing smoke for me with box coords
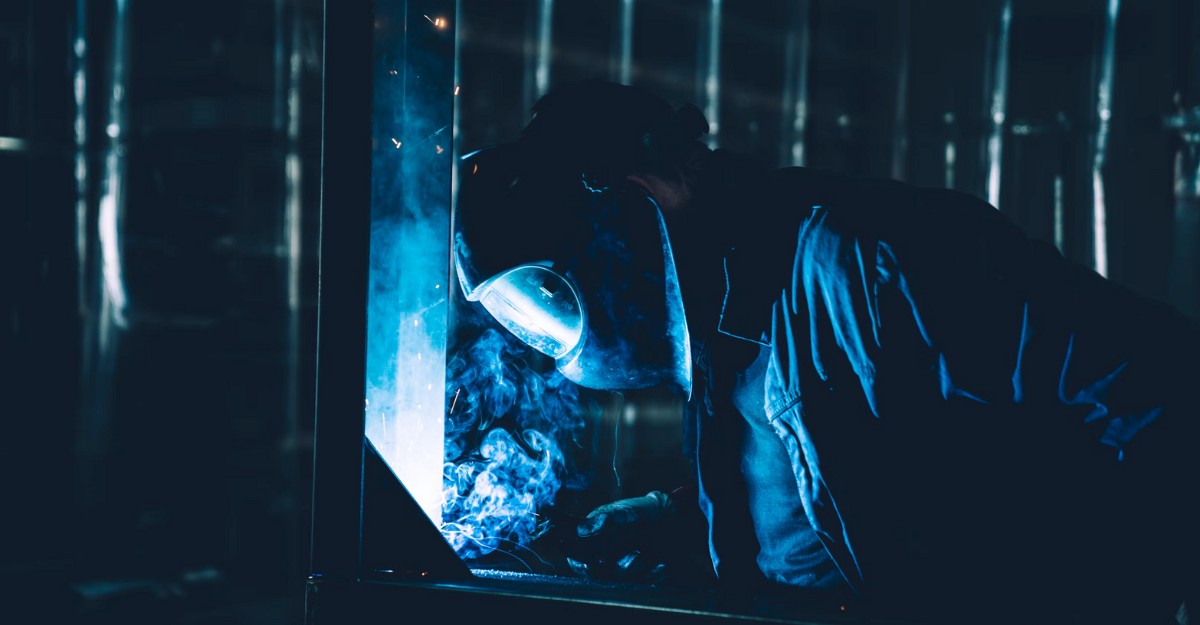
[566,491,677,584]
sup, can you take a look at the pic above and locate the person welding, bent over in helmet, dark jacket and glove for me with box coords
[454,82,1200,624]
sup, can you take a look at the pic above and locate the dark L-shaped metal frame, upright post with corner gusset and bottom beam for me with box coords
[305,0,888,625]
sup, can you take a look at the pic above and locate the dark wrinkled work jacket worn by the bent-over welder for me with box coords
[684,154,1200,623]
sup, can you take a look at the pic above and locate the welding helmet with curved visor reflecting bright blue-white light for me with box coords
[452,144,691,397]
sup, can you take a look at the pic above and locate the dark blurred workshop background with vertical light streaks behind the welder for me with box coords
[0,0,1200,623]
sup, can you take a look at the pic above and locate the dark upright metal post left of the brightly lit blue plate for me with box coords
[310,0,373,579]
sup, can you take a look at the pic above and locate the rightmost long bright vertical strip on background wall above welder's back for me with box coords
[1092,0,1121,276]
